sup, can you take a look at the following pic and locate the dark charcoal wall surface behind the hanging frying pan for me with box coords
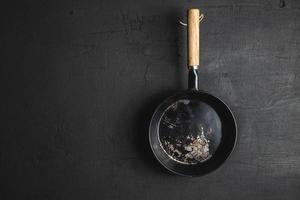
[0,0,300,200]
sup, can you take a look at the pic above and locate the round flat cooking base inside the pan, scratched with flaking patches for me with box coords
[158,98,222,165]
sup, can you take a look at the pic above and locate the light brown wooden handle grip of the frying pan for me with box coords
[187,9,200,66]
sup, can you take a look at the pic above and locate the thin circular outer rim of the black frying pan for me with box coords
[148,89,238,177]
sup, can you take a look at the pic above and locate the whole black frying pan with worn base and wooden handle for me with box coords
[149,9,237,176]
